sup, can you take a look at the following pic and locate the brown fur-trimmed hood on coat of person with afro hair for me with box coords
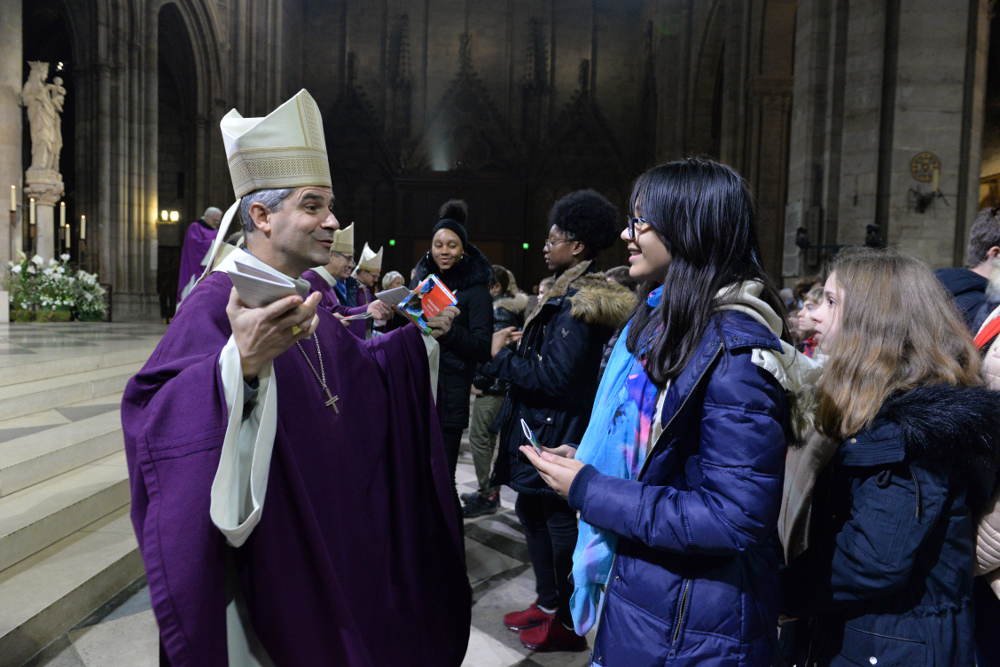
[524,260,638,329]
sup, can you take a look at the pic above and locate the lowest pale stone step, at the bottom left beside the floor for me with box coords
[0,508,143,667]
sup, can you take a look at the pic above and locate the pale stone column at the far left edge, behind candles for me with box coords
[0,2,24,322]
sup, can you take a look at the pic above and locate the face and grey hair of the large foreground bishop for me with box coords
[254,186,340,277]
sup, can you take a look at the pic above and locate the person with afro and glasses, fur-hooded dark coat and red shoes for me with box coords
[481,190,635,651]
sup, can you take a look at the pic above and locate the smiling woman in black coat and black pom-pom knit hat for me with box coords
[414,199,493,486]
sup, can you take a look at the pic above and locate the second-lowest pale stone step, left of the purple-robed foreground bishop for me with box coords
[0,452,129,571]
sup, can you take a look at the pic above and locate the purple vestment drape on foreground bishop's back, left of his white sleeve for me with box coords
[122,276,230,665]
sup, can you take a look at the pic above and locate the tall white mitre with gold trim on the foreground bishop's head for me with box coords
[202,88,333,277]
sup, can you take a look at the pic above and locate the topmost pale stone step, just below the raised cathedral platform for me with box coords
[0,362,142,419]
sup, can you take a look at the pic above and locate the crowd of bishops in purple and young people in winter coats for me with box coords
[122,91,1000,667]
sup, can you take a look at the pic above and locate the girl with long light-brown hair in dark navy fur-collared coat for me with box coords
[785,250,1000,665]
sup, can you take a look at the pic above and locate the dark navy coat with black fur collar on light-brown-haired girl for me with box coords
[784,385,1000,666]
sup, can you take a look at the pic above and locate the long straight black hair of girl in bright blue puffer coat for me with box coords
[626,158,787,386]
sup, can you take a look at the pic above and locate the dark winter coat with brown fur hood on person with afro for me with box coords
[482,261,636,494]
